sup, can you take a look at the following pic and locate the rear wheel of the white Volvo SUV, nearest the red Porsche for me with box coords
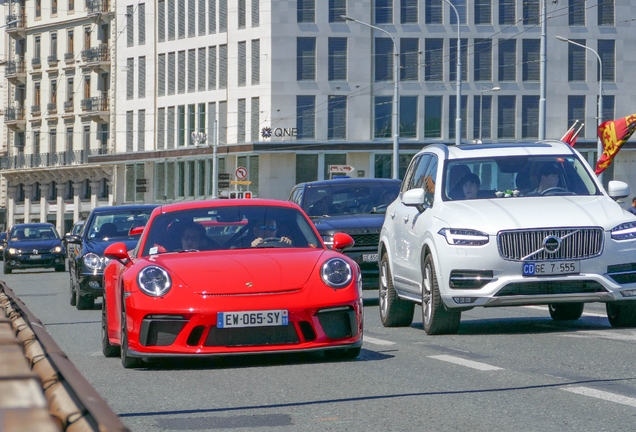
[379,254,415,327]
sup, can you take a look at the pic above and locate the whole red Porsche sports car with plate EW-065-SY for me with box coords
[102,199,363,368]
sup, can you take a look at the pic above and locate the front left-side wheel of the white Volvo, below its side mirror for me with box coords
[422,255,462,335]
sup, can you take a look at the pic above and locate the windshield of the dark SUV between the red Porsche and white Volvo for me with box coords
[303,182,400,217]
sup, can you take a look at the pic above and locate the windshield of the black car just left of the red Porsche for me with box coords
[87,209,153,241]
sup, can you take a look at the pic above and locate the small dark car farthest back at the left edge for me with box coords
[3,223,66,274]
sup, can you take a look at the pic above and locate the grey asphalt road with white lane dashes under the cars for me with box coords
[3,264,636,432]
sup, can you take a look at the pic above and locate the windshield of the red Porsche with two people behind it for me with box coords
[142,205,323,256]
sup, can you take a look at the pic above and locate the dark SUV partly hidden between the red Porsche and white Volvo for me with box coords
[289,178,402,289]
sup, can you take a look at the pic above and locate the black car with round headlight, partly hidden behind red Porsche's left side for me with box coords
[66,205,157,310]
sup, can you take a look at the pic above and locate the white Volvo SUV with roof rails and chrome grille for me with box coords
[378,141,636,334]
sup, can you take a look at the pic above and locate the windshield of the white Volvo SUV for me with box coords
[442,155,600,201]
